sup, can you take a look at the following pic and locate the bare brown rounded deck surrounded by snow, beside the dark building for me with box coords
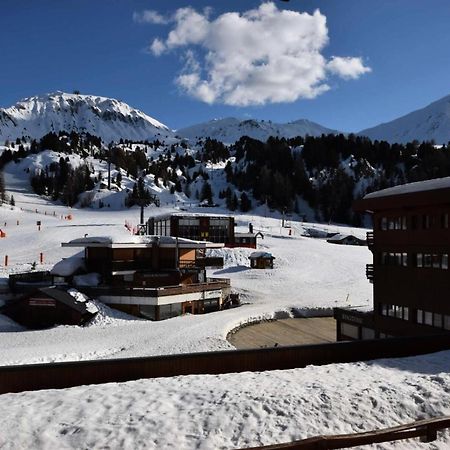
[228,317,336,349]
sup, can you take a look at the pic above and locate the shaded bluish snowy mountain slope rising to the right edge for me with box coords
[358,95,450,144]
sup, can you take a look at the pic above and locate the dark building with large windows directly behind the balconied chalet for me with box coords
[146,214,264,248]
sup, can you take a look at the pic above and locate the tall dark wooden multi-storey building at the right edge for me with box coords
[335,177,450,339]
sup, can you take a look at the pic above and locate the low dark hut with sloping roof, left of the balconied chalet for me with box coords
[2,286,97,329]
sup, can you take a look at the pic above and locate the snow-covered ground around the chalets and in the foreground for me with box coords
[0,160,450,449]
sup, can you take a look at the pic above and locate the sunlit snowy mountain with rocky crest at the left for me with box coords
[0,92,173,142]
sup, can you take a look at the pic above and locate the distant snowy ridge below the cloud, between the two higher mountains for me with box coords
[177,117,338,144]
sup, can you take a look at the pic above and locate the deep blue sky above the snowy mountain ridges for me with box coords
[0,0,450,131]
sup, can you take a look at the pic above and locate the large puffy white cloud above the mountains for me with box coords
[143,2,370,106]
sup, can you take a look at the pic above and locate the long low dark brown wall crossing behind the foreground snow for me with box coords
[0,334,450,394]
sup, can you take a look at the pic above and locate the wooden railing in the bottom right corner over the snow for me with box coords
[241,416,450,450]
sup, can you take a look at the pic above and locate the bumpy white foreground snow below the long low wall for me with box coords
[0,354,450,450]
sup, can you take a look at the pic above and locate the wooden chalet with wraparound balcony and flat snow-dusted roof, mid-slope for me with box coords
[62,236,230,320]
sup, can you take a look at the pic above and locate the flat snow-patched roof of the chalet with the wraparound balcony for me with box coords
[62,235,224,248]
